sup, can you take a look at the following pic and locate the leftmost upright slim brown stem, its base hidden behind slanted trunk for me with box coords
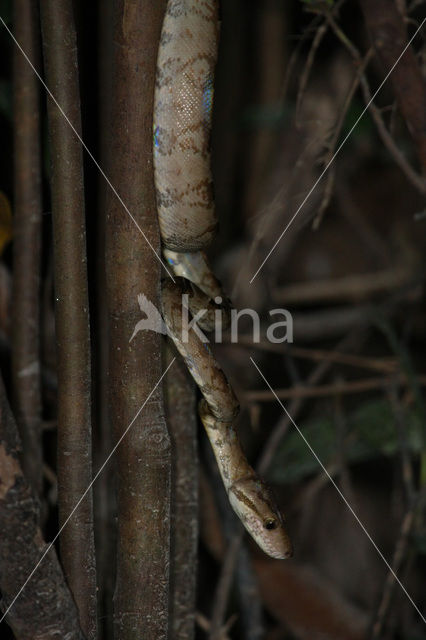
[11,0,42,495]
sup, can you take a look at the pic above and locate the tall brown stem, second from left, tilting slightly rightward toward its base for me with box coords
[40,0,96,638]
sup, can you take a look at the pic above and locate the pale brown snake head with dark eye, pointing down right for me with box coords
[228,472,293,560]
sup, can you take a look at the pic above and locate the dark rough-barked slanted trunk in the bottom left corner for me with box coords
[0,380,84,640]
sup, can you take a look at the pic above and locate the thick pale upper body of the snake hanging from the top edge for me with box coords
[154,0,218,252]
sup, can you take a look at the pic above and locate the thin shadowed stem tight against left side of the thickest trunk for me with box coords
[93,0,116,640]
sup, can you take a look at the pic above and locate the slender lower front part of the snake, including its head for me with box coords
[162,281,292,559]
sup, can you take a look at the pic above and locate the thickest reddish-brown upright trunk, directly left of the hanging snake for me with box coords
[106,0,171,640]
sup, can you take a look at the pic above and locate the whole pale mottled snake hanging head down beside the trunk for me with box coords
[153,0,292,559]
